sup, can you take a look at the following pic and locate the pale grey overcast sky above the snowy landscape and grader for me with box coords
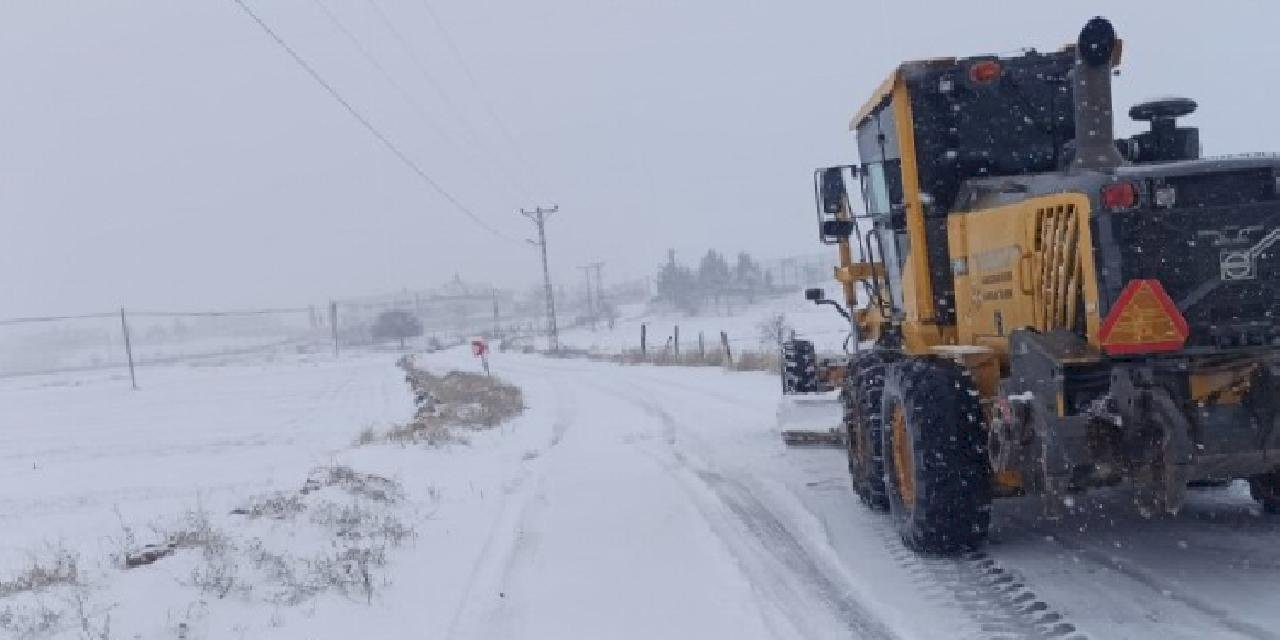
[0,0,1280,317]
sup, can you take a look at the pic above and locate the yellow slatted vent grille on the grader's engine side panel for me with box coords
[1019,205,1083,332]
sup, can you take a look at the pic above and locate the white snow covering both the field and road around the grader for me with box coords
[0,343,1280,640]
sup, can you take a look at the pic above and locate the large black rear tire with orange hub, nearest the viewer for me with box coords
[881,357,991,554]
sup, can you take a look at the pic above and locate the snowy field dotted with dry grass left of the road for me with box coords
[0,356,535,640]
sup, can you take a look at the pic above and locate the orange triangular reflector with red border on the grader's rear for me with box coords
[1098,280,1190,356]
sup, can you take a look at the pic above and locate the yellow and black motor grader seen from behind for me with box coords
[810,18,1280,552]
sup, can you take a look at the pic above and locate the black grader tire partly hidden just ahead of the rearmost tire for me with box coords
[841,352,893,512]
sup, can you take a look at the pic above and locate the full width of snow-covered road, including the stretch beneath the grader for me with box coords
[427,358,1280,639]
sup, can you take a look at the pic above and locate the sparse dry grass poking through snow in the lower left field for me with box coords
[0,465,416,640]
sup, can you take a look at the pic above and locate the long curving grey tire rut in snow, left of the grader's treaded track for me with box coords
[589,380,897,640]
